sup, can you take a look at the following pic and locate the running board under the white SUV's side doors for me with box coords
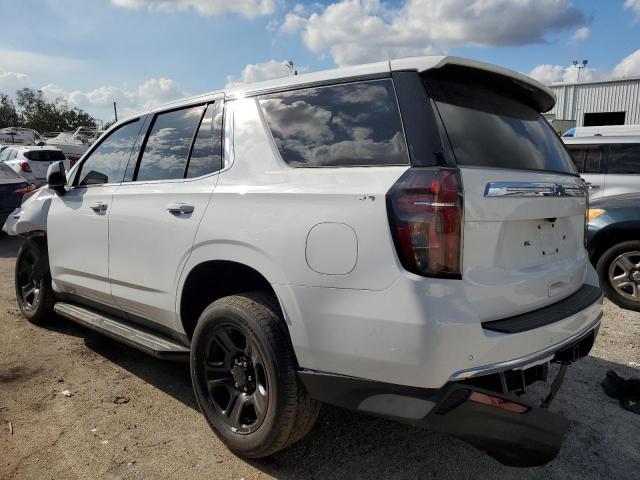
[53,302,189,361]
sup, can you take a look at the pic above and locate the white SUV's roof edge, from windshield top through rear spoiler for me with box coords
[118,56,555,123]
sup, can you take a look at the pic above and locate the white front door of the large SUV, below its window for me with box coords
[47,185,117,306]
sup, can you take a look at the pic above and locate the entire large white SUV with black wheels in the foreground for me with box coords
[4,57,602,465]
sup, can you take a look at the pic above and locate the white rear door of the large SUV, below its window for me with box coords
[109,175,218,326]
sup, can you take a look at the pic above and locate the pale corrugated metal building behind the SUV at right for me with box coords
[546,77,640,128]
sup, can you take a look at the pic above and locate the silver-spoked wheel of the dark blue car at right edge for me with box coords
[596,240,640,311]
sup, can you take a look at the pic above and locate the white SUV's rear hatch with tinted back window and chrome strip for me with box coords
[423,67,587,321]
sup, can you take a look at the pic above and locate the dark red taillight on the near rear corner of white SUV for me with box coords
[387,168,462,278]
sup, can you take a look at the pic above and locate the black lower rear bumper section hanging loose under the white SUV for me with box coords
[300,319,599,467]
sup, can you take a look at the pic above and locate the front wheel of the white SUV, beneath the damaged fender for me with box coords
[14,237,56,325]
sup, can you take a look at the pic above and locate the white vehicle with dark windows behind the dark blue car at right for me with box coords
[562,135,640,200]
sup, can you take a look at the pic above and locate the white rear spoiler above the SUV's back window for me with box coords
[389,56,556,113]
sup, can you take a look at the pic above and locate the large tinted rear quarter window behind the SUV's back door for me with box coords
[259,80,409,167]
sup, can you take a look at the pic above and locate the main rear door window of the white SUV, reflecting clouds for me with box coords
[136,106,205,181]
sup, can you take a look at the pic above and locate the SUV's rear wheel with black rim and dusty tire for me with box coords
[191,292,320,458]
